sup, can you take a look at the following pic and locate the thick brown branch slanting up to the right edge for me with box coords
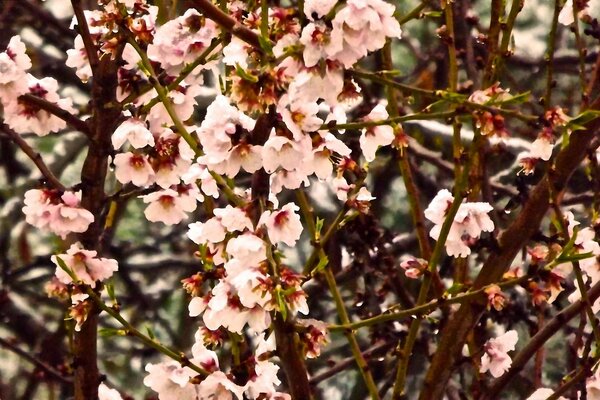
[420,101,600,400]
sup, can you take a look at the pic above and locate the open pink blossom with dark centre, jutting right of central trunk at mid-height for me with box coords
[258,203,302,246]
